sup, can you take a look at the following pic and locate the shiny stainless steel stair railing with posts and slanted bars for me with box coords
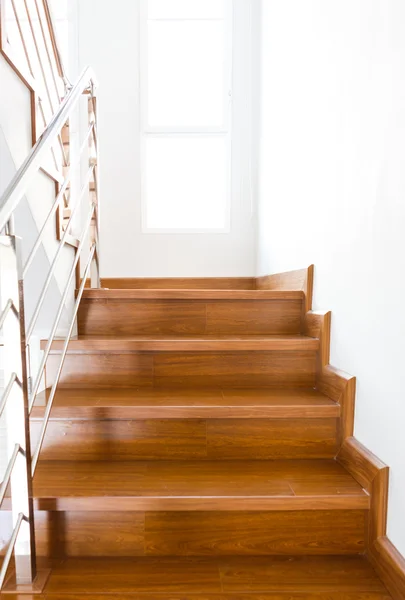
[0,63,100,590]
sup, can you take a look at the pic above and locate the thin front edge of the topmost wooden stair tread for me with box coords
[82,288,304,300]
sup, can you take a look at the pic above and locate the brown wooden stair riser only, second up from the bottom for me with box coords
[31,418,337,460]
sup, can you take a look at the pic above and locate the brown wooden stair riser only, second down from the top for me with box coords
[46,350,316,388]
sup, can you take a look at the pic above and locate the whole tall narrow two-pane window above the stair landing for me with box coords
[141,0,232,232]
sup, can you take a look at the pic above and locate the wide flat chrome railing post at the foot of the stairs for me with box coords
[0,236,36,584]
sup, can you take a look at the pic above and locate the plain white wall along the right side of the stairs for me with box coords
[258,0,405,554]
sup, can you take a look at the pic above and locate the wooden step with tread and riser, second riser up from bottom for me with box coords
[31,389,340,460]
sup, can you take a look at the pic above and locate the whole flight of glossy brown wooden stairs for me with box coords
[4,270,390,600]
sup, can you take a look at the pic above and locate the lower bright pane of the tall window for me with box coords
[146,136,227,230]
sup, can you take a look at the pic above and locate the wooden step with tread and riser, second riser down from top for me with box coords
[42,335,319,388]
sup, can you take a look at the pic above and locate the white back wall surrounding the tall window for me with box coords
[77,0,255,277]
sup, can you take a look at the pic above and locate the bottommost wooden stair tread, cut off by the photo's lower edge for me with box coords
[6,556,391,600]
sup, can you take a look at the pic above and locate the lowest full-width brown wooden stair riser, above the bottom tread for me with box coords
[35,510,365,558]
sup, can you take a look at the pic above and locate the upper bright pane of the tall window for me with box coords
[148,21,225,127]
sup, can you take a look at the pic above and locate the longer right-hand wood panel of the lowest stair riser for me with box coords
[145,510,364,556]
